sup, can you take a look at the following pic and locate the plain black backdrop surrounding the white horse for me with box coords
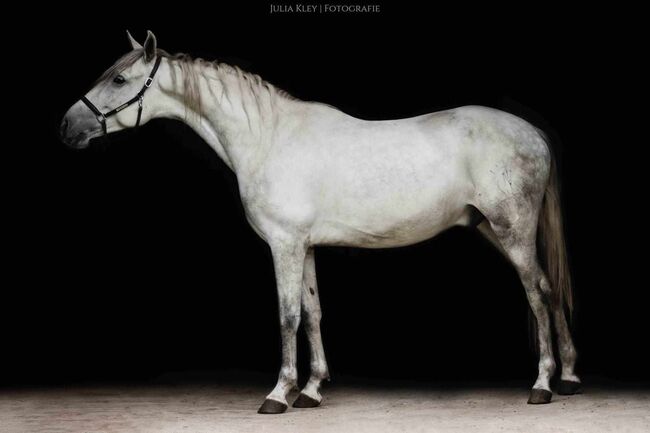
[0,2,649,384]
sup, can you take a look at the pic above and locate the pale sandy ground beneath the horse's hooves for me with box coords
[0,372,650,433]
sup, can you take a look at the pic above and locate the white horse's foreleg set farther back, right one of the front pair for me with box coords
[293,248,329,408]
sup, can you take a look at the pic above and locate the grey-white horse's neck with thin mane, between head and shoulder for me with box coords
[161,58,301,174]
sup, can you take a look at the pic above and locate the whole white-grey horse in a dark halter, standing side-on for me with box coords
[61,32,580,413]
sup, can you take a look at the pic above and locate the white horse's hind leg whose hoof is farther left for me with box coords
[482,211,555,404]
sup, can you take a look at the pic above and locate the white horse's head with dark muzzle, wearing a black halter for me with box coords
[60,32,160,149]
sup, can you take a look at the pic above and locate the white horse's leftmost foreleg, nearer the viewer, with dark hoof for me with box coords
[258,241,306,413]
